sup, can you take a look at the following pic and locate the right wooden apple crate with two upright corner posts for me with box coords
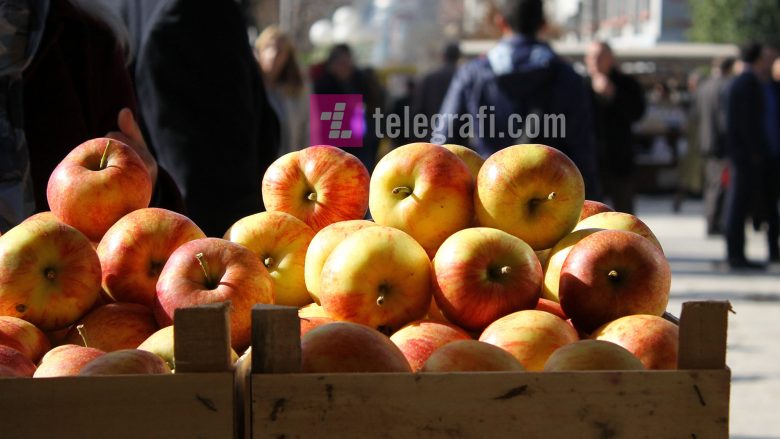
[236,302,731,439]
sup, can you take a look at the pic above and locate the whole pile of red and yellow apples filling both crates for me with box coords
[0,138,677,377]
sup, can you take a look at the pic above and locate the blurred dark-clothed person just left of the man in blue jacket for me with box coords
[412,42,460,124]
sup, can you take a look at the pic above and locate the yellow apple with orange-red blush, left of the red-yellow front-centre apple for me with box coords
[320,226,431,334]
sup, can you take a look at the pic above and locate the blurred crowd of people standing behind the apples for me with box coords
[0,0,780,269]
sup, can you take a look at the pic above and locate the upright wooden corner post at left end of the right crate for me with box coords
[252,304,301,373]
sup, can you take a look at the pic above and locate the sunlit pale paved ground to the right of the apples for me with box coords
[638,197,780,439]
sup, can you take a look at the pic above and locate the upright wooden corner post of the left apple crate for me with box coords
[173,302,233,373]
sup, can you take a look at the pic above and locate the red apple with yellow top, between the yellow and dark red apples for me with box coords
[433,227,542,331]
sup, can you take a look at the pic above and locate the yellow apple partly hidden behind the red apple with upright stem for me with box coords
[225,212,314,307]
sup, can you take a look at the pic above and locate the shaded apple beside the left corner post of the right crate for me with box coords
[301,322,411,373]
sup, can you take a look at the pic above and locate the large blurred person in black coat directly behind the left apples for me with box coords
[101,0,280,237]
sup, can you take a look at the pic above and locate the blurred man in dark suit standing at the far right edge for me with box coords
[724,42,780,269]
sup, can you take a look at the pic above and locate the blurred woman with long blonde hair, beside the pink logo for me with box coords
[255,26,309,156]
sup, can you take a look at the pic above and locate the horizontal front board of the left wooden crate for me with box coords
[0,372,234,439]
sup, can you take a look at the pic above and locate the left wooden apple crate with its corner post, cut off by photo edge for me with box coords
[0,305,237,439]
